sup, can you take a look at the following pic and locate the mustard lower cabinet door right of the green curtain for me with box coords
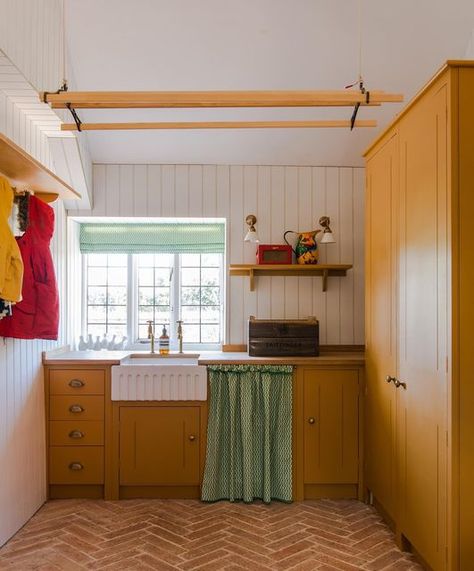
[300,367,359,484]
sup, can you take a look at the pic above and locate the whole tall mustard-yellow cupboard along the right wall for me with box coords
[366,61,474,571]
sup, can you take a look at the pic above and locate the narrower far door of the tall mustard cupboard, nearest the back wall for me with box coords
[365,133,399,519]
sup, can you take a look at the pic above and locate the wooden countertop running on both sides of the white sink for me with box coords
[43,350,365,366]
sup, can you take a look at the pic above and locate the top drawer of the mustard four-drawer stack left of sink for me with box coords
[49,369,105,395]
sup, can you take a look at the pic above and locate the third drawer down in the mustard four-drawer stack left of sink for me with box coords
[49,420,104,446]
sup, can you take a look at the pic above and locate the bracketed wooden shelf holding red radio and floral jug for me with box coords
[230,264,352,291]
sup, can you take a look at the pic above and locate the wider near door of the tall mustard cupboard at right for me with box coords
[397,78,448,569]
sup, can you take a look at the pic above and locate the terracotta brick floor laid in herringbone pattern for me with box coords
[0,500,421,571]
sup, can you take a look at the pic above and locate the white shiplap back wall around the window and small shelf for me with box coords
[78,164,364,344]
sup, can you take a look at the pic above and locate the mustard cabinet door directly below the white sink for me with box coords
[120,406,200,486]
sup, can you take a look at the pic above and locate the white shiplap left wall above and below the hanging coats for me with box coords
[0,0,66,545]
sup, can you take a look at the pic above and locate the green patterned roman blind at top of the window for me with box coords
[80,222,225,254]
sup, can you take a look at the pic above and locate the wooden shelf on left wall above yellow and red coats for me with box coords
[0,133,81,202]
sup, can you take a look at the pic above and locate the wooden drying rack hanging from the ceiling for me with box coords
[40,89,403,131]
